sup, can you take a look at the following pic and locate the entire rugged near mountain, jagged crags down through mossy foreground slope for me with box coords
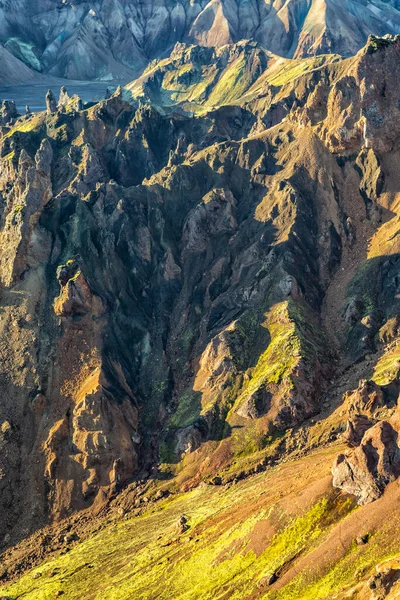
[0,34,400,600]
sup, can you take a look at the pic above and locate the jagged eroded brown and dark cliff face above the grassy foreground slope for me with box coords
[0,38,400,545]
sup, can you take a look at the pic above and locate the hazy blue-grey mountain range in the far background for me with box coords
[0,0,400,81]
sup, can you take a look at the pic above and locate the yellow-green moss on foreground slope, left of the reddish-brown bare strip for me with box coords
[0,451,368,600]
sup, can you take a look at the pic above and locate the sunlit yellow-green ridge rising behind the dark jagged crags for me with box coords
[127,43,338,112]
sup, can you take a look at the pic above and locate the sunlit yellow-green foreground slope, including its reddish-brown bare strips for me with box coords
[0,447,400,600]
